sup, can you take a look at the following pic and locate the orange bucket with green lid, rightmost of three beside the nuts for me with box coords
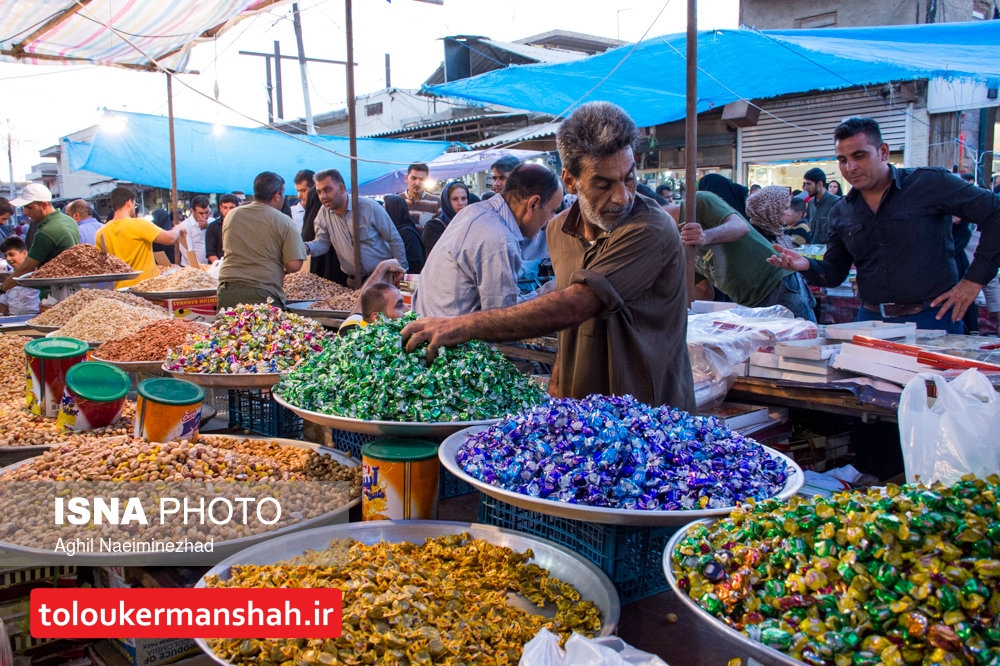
[135,377,205,442]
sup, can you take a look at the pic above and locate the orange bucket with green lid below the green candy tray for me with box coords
[361,439,441,520]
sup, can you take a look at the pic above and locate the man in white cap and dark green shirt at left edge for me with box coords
[0,183,80,295]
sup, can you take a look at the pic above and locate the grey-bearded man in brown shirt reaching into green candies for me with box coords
[403,102,695,410]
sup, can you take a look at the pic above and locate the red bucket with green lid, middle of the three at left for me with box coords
[56,361,131,430]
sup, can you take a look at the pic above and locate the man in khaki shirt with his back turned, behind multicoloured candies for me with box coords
[218,171,306,311]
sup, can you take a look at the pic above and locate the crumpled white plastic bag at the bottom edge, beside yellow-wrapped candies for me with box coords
[520,629,667,666]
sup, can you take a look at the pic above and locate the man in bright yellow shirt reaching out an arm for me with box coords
[96,187,184,289]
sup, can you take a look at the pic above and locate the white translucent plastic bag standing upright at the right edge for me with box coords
[899,369,1000,484]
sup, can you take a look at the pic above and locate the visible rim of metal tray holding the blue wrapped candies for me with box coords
[438,427,805,526]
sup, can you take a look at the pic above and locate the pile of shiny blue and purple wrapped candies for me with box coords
[456,395,791,511]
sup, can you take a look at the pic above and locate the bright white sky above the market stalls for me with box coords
[0,0,739,184]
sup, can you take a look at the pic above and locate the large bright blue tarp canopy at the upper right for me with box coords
[425,21,1000,126]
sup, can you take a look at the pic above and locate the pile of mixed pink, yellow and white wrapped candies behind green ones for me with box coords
[166,301,326,374]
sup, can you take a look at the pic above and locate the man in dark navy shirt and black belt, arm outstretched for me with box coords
[767,118,1000,333]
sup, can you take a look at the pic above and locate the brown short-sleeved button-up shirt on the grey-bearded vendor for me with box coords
[548,195,695,411]
